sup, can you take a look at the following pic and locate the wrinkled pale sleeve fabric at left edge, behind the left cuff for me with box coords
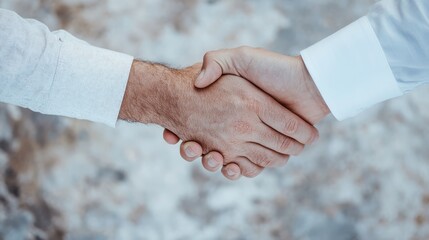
[0,9,61,110]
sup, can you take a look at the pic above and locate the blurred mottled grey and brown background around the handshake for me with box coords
[0,0,429,240]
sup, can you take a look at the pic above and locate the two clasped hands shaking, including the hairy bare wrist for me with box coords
[119,47,330,180]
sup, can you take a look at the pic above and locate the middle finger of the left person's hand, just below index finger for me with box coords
[253,124,304,156]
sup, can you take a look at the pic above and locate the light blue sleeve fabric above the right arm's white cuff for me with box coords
[367,0,429,92]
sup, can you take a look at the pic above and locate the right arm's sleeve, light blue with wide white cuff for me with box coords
[301,0,429,120]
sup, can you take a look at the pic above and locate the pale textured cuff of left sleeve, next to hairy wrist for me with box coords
[41,32,133,127]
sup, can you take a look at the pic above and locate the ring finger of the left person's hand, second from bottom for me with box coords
[244,143,289,168]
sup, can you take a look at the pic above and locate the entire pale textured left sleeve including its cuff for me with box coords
[0,9,133,126]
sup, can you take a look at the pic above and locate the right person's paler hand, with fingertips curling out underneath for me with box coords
[164,47,330,180]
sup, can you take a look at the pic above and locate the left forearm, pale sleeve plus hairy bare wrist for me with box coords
[0,9,197,127]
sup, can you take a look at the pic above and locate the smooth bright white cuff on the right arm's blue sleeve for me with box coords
[301,17,402,120]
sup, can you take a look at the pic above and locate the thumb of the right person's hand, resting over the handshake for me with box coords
[195,50,236,88]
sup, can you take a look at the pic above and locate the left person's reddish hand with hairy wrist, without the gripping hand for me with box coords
[119,61,318,177]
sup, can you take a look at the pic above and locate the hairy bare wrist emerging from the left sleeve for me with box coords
[119,60,200,130]
